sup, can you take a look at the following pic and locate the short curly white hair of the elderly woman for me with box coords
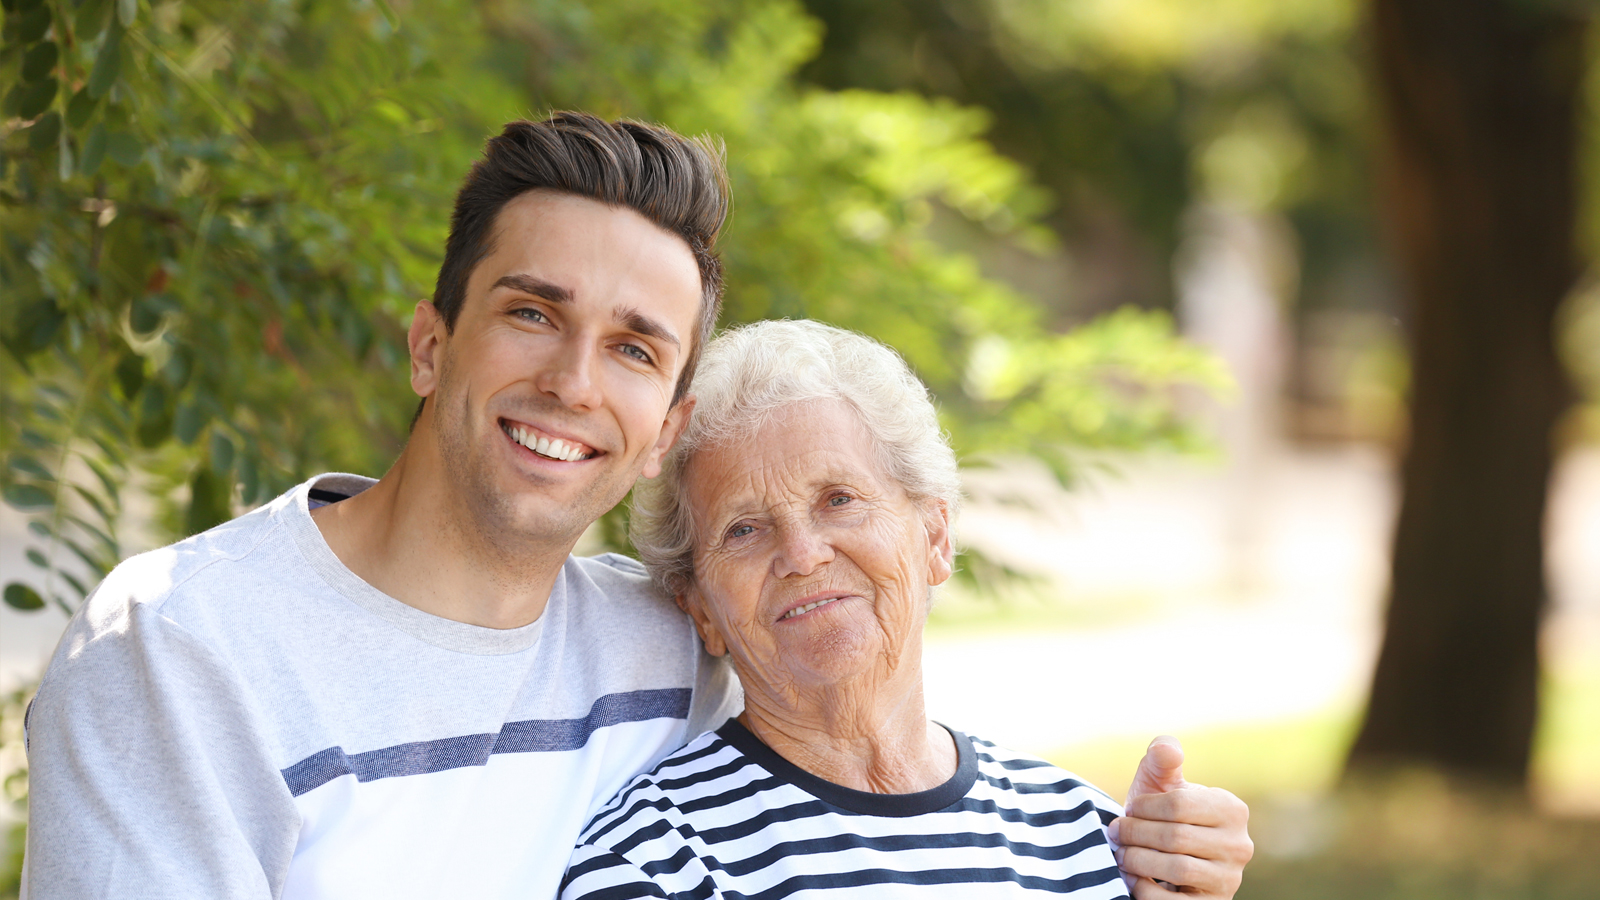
[629,320,962,596]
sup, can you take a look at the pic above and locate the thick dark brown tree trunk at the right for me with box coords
[1347,0,1587,788]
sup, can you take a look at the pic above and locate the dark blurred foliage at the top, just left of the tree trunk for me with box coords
[803,0,1373,325]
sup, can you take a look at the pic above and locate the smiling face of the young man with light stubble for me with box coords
[411,191,701,543]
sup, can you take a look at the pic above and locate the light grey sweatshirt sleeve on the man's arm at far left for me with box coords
[22,586,299,900]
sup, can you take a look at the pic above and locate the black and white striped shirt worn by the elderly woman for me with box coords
[562,719,1128,900]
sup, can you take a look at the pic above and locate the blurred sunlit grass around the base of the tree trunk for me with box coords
[1048,661,1600,900]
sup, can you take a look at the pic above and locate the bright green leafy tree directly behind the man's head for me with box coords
[0,0,1221,610]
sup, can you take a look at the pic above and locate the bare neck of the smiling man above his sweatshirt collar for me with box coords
[312,448,578,628]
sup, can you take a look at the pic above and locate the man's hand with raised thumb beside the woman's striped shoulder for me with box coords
[1110,735,1256,900]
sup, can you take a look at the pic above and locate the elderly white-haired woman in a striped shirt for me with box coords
[562,322,1248,900]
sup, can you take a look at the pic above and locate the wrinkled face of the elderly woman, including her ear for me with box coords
[682,400,950,692]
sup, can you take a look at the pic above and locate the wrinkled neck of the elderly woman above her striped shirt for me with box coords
[739,673,957,794]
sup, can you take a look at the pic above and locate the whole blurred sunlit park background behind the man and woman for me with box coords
[0,0,1600,898]
